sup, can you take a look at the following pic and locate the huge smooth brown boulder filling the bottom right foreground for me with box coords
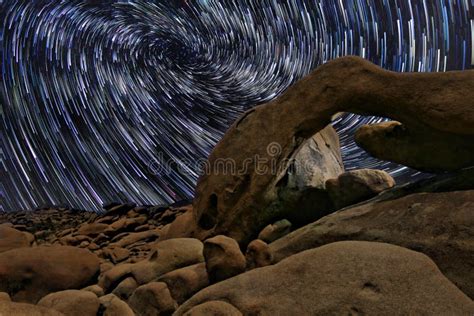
[175,241,474,316]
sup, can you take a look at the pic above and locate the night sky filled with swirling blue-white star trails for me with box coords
[0,0,474,210]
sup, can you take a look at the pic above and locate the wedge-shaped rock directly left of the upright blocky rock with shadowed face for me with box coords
[157,263,209,304]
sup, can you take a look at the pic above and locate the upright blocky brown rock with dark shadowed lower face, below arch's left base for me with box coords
[204,235,246,283]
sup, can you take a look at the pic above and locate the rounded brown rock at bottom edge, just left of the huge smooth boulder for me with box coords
[128,282,178,316]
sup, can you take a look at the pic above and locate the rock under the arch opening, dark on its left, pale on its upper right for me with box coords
[326,169,395,209]
